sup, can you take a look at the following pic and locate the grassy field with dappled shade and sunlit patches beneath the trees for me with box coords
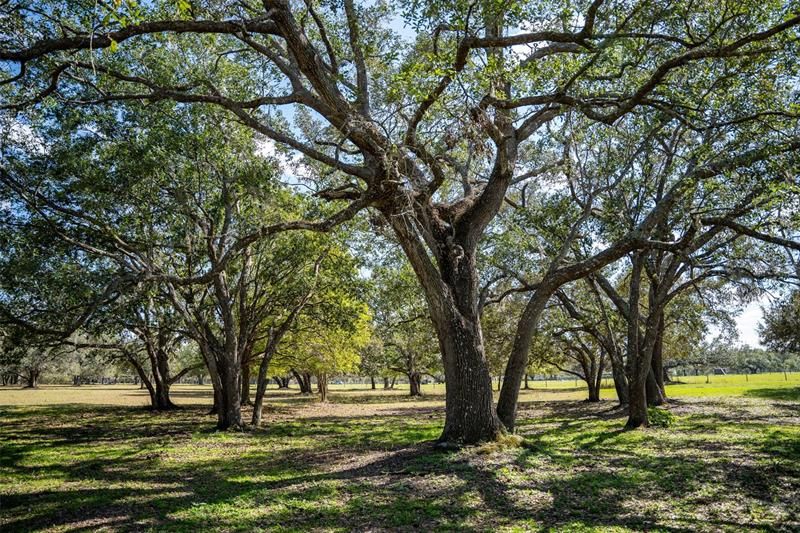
[0,374,800,531]
